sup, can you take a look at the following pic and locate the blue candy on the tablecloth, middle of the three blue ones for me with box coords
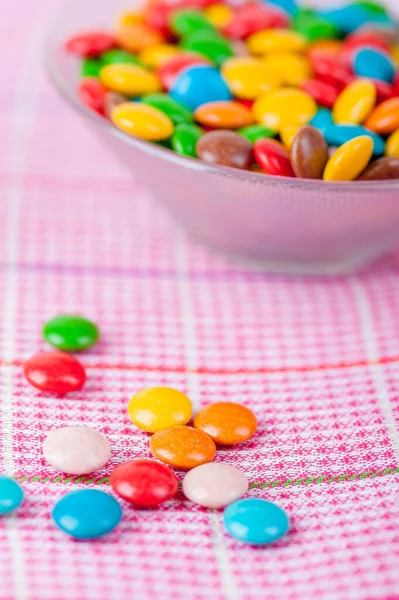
[52,490,122,540]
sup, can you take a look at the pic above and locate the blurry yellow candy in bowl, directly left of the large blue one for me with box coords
[100,64,162,97]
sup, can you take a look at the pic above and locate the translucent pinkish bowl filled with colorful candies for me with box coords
[46,0,399,274]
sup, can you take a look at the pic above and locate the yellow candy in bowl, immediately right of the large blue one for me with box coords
[221,56,282,100]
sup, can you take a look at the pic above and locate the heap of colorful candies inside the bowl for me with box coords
[65,0,399,181]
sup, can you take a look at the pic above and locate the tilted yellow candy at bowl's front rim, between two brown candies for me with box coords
[323,135,374,181]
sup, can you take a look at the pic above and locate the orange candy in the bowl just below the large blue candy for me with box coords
[194,100,254,129]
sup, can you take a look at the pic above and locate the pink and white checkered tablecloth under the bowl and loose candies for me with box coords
[0,0,399,600]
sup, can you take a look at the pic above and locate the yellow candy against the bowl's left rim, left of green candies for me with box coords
[111,102,173,142]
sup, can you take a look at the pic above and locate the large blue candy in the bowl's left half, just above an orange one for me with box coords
[170,65,232,111]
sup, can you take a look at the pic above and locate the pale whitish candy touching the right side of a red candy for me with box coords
[183,462,248,509]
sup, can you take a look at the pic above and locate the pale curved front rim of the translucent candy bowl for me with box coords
[44,23,399,193]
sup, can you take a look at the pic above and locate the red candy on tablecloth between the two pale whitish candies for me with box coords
[110,460,177,507]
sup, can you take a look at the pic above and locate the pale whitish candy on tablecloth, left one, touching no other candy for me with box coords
[43,426,111,475]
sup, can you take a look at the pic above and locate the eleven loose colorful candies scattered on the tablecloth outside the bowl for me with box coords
[0,316,289,545]
